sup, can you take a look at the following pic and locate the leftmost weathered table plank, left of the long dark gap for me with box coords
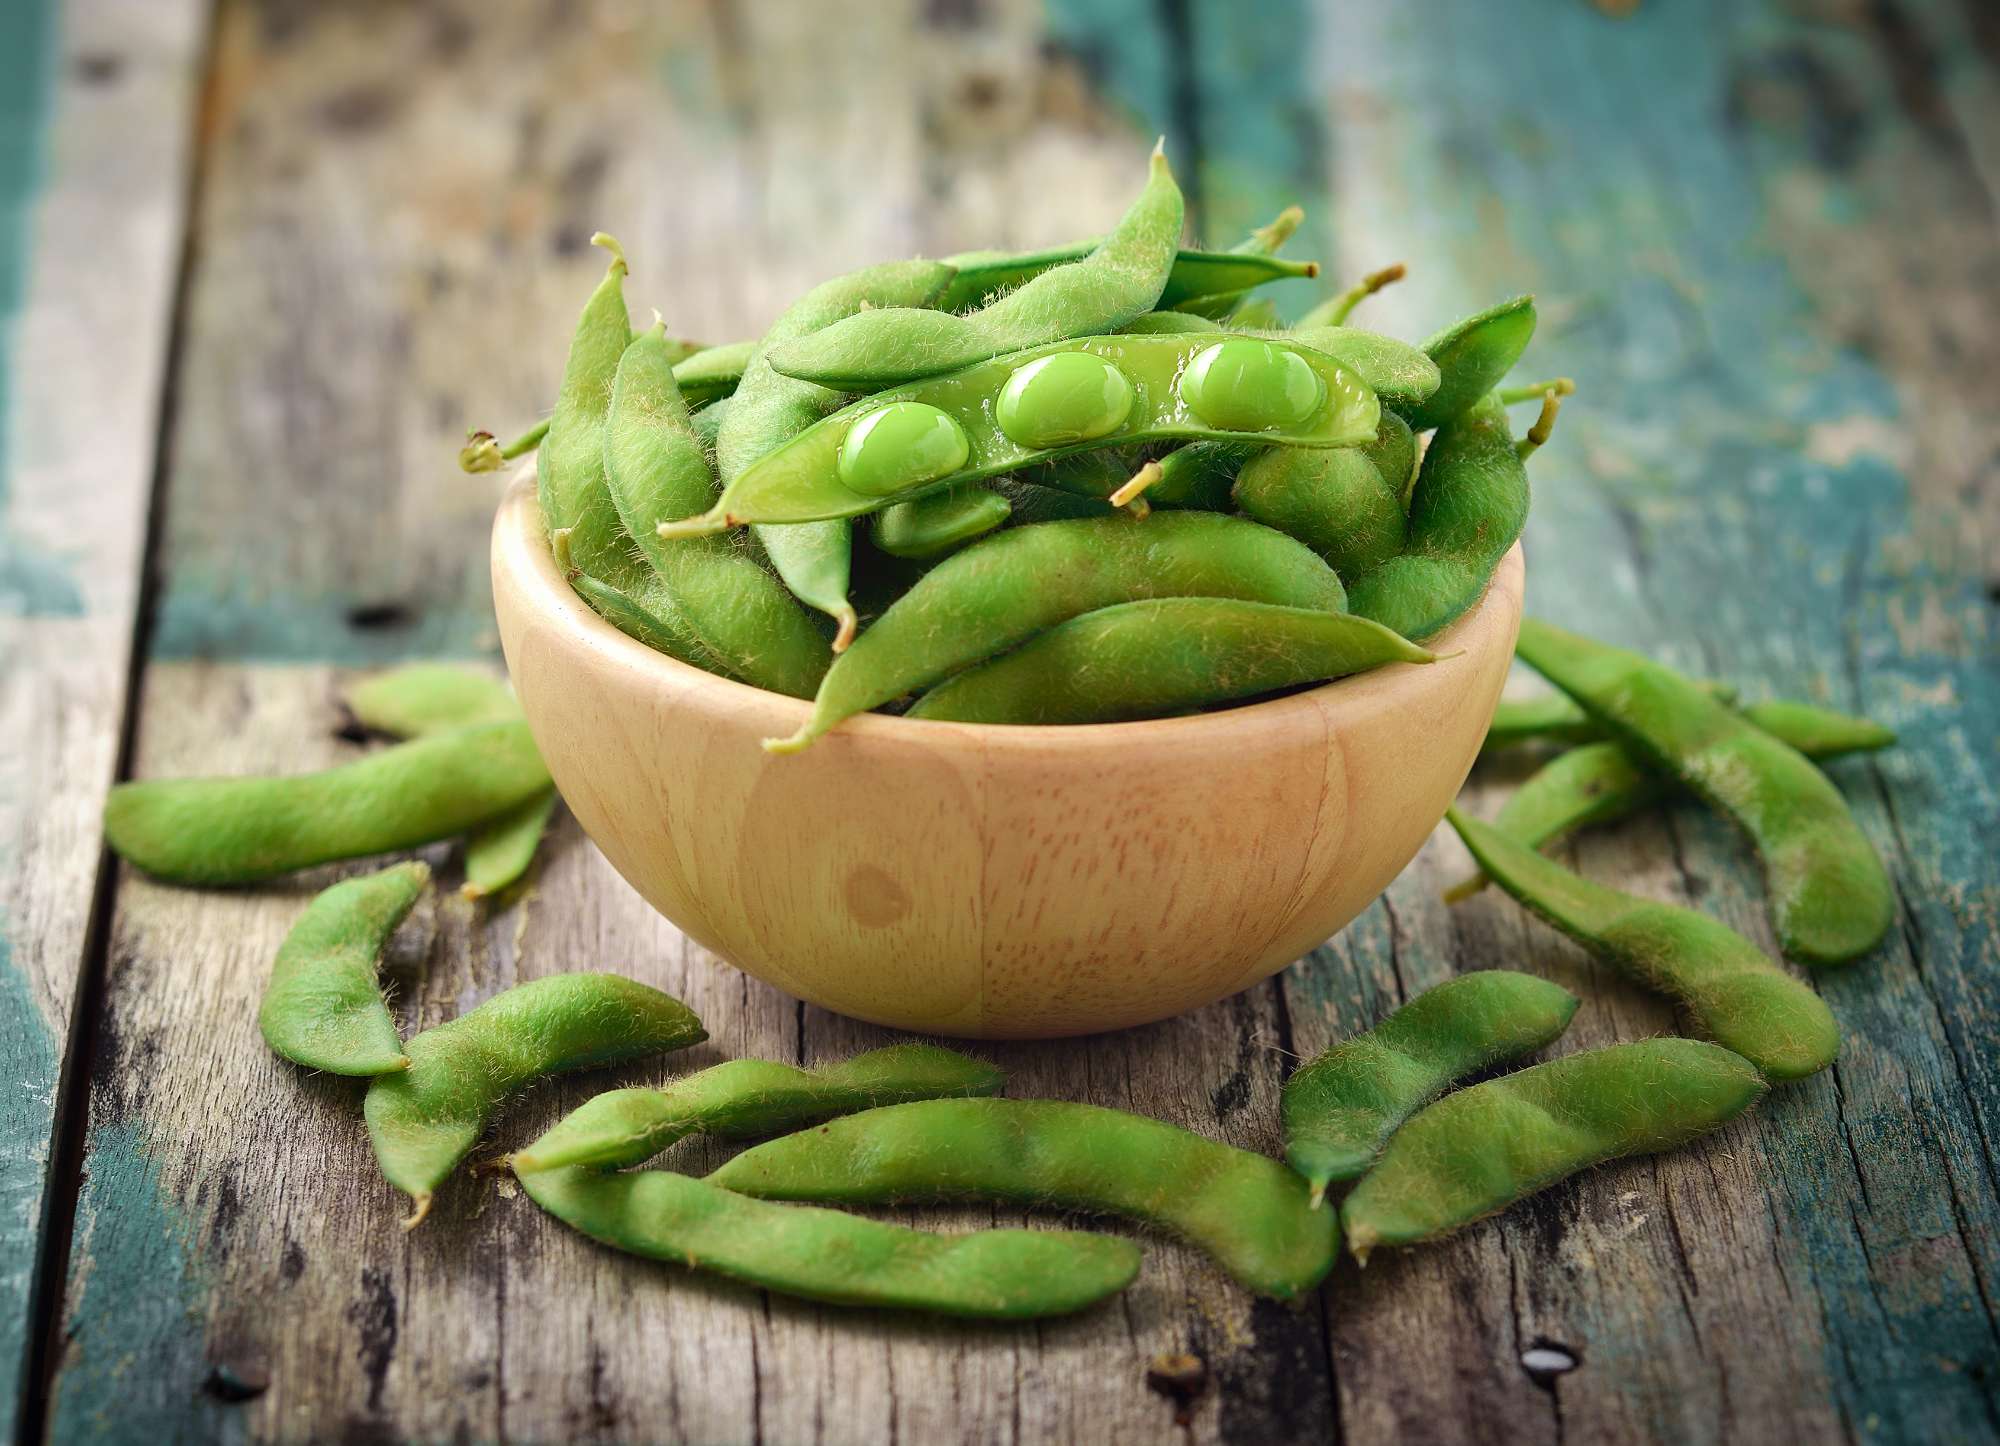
[0,0,204,1436]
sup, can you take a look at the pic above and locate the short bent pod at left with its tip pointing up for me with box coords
[256,862,430,1074]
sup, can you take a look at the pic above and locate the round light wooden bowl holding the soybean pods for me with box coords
[492,478,1522,1038]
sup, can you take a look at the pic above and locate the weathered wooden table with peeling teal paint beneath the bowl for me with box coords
[0,0,2000,1442]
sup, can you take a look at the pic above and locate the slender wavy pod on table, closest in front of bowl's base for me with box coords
[512,1044,1006,1172]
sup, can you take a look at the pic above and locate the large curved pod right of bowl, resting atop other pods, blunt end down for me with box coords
[1516,618,1896,964]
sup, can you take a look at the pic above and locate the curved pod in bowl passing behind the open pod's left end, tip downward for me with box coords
[720,260,952,652]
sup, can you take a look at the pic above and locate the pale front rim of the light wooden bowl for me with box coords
[492,476,1524,754]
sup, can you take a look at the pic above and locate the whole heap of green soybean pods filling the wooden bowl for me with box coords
[460,150,1570,752]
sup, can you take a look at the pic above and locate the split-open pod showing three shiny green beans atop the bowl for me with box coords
[660,334,1380,536]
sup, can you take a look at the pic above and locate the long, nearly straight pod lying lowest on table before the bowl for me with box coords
[520,1166,1140,1320]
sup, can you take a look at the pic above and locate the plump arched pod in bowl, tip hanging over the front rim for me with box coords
[764,512,1346,752]
